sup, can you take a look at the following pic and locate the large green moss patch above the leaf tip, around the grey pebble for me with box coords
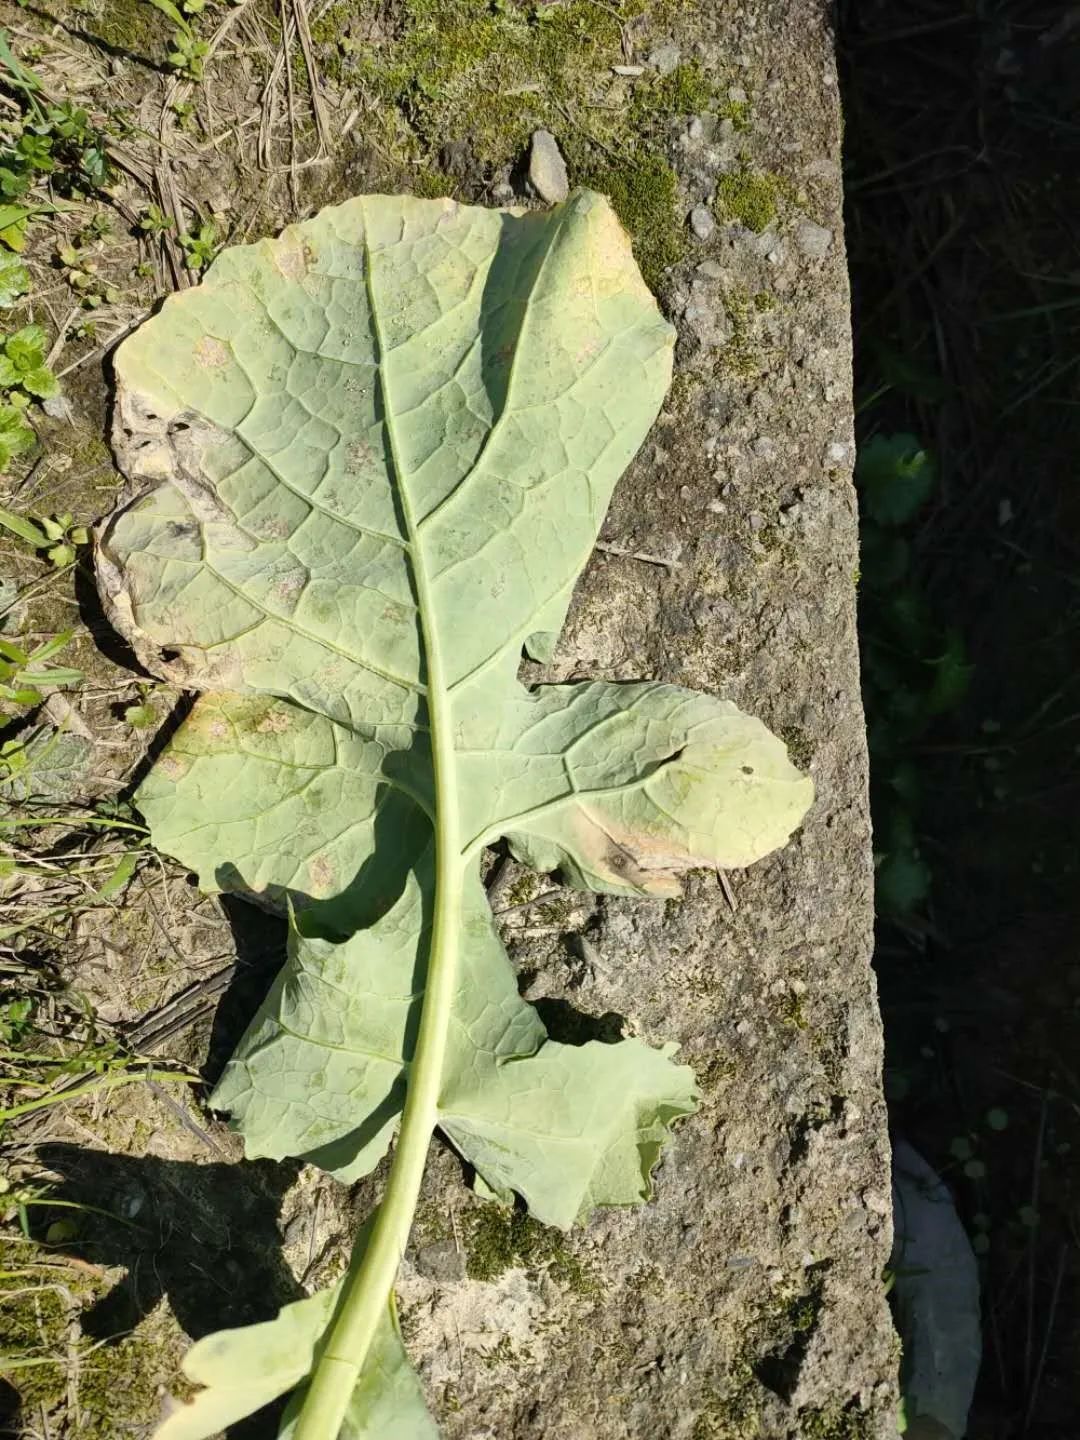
[312,0,719,288]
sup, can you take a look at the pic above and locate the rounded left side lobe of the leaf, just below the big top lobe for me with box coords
[138,694,432,935]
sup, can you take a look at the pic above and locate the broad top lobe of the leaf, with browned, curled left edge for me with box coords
[99,192,674,726]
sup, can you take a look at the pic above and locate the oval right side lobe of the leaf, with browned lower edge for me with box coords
[461,683,814,894]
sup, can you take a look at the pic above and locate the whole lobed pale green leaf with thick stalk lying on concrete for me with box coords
[98,193,812,1440]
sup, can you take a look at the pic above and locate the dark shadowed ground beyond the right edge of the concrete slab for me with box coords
[841,0,1080,1440]
